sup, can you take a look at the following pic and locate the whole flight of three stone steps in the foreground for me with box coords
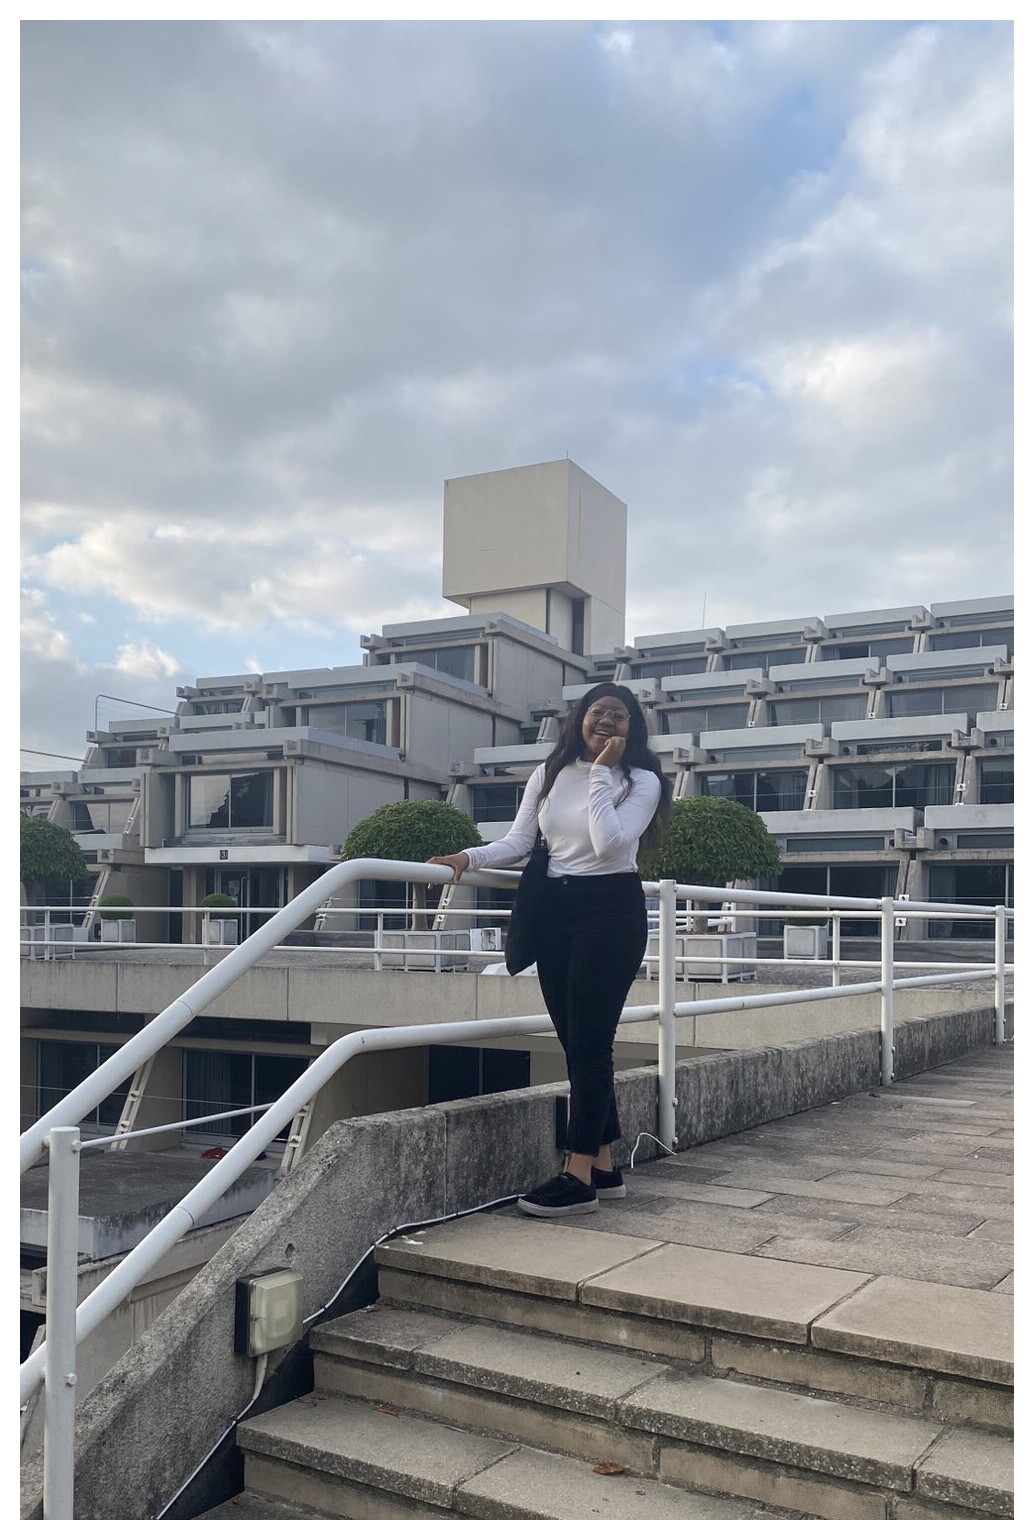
[202,1209,1012,1520]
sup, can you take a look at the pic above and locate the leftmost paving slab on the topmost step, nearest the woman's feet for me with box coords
[374,1214,656,1300]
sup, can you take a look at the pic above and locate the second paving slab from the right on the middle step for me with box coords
[619,1372,942,1491]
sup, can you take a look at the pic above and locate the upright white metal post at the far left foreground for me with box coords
[43,1129,80,1518]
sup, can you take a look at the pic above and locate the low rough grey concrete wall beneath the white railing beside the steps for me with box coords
[22,1001,994,1520]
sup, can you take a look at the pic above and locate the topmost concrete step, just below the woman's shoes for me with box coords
[376,1212,1012,1431]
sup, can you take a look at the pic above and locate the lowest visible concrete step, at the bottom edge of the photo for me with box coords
[237,1394,767,1520]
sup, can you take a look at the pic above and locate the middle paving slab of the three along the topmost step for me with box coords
[579,1244,869,1343]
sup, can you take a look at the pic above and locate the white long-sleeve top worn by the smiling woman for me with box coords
[464,759,661,876]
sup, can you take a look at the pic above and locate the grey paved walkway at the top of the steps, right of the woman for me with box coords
[507,1046,1012,1295]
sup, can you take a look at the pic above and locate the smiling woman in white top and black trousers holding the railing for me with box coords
[433,684,672,1218]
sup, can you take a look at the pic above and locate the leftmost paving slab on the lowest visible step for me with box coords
[237,1395,516,1508]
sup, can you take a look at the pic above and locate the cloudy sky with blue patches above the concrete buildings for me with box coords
[22,20,1012,768]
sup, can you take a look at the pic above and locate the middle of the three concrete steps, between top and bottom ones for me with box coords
[310,1303,1012,1518]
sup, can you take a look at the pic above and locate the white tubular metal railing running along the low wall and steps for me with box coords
[20,861,1012,1518]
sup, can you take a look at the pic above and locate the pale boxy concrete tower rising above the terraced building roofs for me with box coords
[442,460,629,653]
